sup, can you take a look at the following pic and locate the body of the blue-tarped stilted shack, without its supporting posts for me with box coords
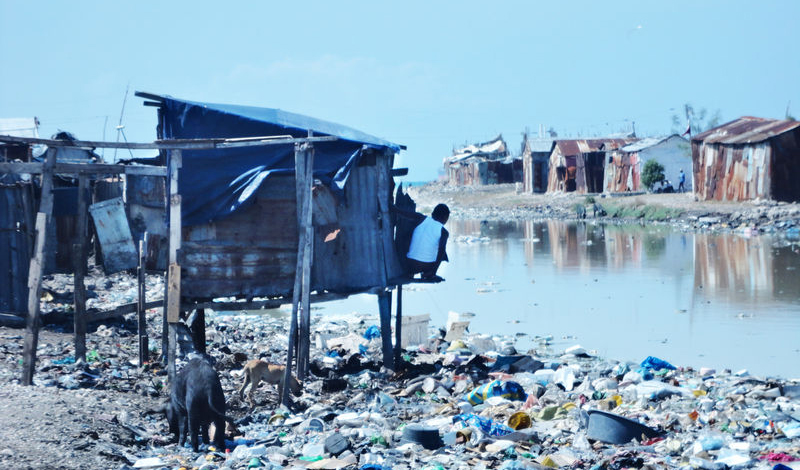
[138,93,403,302]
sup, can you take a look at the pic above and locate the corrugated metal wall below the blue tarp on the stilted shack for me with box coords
[181,156,401,299]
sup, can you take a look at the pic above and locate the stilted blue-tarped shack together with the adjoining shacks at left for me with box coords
[0,93,422,402]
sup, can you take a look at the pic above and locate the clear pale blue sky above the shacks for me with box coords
[0,0,800,181]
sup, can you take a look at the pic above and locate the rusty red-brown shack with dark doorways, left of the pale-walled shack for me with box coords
[547,138,636,194]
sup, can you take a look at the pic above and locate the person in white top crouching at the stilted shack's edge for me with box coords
[406,204,450,282]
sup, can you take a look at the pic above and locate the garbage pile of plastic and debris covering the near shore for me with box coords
[134,314,800,470]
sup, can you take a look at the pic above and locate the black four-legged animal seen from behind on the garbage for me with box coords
[165,358,225,452]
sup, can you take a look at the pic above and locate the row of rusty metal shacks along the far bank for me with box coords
[445,116,800,201]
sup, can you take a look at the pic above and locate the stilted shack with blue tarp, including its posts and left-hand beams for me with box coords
[0,93,422,401]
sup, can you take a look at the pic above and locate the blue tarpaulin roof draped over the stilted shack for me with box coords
[140,93,401,225]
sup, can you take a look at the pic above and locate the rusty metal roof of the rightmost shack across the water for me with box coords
[692,116,800,144]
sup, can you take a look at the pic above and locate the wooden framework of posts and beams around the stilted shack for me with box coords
[0,132,413,402]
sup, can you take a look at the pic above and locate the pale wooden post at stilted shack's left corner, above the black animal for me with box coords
[164,150,182,382]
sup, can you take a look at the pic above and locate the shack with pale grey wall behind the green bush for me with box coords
[603,134,692,193]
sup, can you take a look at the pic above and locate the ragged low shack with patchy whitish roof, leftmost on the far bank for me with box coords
[444,135,522,186]
